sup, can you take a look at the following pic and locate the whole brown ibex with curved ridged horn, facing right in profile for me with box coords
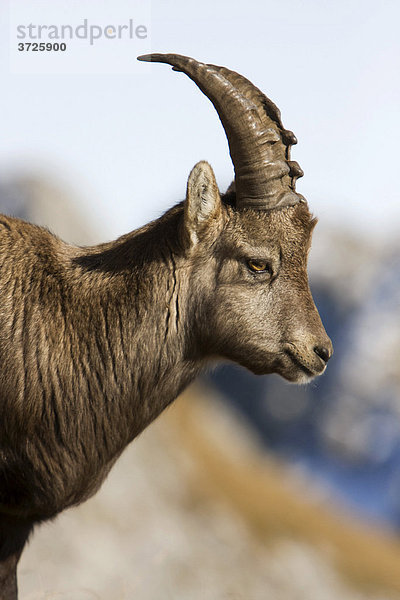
[0,54,332,600]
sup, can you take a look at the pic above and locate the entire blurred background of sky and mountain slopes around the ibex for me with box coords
[0,0,400,600]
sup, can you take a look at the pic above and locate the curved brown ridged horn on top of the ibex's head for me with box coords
[138,54,304,210]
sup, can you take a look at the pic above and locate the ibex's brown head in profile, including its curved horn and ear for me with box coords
[139,54,332,382]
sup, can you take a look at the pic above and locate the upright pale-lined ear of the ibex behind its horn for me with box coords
[184,160,222,246]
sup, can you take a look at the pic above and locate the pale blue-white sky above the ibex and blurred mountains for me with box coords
[0,0,400,237]
